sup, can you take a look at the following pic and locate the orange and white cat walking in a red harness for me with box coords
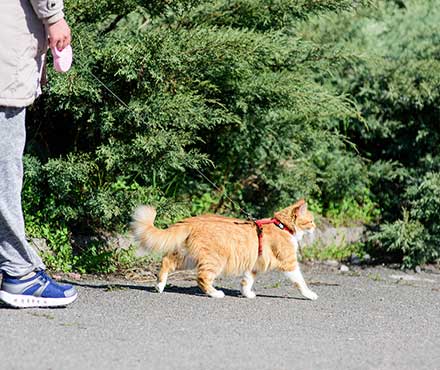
[132,200,318,300]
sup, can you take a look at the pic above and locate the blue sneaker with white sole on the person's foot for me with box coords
[0,271,78,308]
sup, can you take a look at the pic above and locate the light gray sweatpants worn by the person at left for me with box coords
[0,106,45,276]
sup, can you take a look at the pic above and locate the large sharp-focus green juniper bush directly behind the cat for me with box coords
[23,0,368,269]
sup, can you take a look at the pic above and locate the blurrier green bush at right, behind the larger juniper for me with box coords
[305,0,440,266]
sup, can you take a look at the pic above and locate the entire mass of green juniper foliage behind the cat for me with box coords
[23,0,440,270]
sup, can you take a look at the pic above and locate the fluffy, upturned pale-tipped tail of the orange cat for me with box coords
[131,206,189,253]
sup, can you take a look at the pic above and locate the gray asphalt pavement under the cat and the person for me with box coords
[0,266,440,370]
